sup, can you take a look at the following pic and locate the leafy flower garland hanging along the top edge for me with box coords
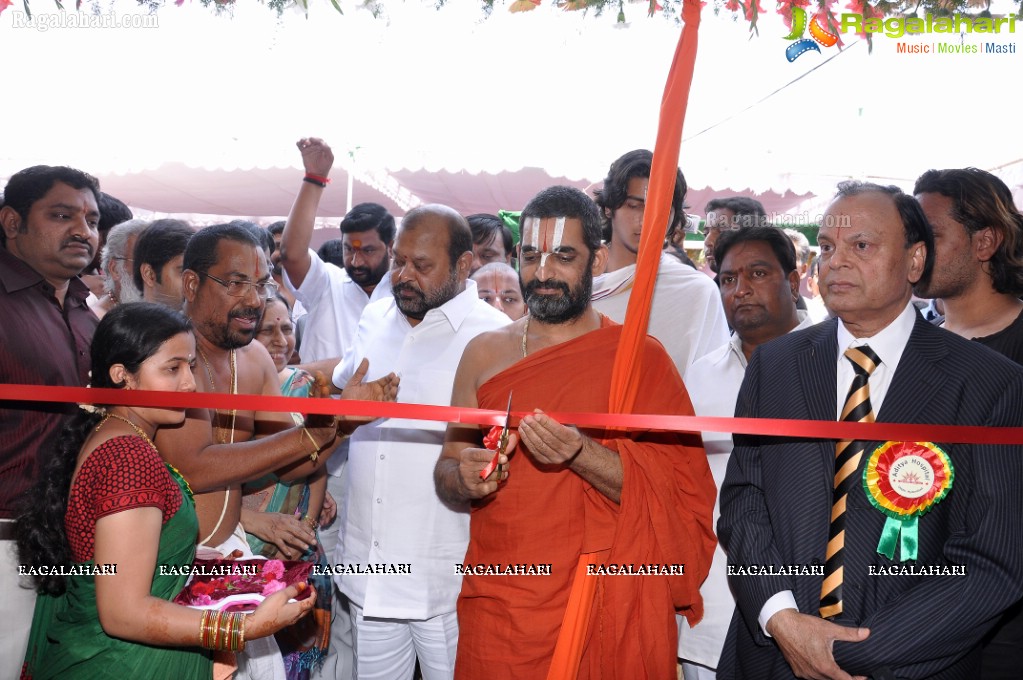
[0,0,1023,32]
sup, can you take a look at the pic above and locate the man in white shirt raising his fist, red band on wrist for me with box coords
[279,138,395,680]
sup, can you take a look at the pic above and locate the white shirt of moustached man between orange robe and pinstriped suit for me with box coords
[677,310,813,668]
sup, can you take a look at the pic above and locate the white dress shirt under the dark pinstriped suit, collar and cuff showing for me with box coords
[759,302,918,637]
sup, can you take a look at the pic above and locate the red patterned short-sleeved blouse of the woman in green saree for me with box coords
[64,435,182,562]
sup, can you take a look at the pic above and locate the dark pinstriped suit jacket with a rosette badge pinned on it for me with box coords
[718,318,1023,679]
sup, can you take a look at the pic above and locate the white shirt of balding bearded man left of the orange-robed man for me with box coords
[333,280,509,620]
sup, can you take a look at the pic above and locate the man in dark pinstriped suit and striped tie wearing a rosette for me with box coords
[718,183,1023,680]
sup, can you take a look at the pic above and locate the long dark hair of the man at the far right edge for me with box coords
[913,168,1023,298]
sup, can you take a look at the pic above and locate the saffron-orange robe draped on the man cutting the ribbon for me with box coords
[455,318,716,680]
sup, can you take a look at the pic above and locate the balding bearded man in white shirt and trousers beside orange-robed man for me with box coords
[333,206,508,680]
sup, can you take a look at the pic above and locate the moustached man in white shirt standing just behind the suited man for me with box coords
[678,227,812,680]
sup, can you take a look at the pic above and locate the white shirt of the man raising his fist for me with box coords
[283,251,391,361]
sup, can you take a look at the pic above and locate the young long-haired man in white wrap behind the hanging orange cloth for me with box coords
[593,149,728,374]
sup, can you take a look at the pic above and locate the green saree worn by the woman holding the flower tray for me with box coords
[23,466,213,680]
